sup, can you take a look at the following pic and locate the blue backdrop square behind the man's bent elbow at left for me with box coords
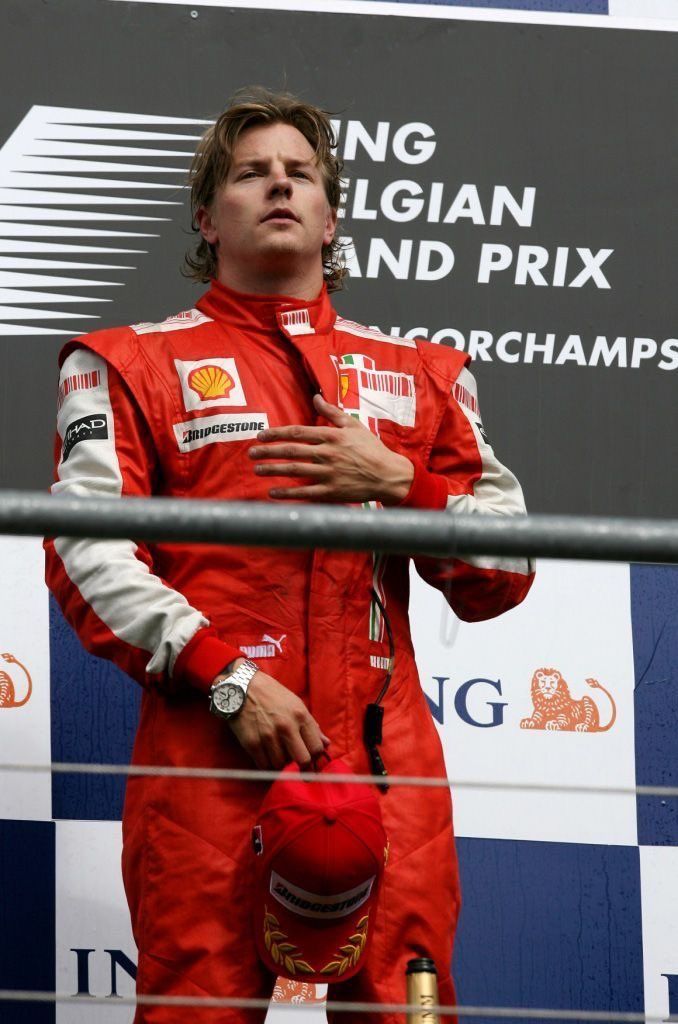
[49,597,139,820]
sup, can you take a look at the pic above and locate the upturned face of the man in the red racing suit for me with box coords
[198,123,337,288]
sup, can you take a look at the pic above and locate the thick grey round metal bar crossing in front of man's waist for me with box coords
[0,490,678,562]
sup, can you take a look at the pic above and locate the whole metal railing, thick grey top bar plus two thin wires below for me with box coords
[0,490,678,1024]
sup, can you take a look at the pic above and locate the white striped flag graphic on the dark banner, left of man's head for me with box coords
[0,106,209,336]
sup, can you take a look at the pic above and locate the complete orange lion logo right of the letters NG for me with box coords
[520,669,617,732]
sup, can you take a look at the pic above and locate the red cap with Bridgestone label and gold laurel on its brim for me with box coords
[252,760,388,983]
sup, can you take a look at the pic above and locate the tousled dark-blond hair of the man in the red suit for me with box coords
[183,86,347,292]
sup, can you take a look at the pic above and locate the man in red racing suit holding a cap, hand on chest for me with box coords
[47,90,533,1024]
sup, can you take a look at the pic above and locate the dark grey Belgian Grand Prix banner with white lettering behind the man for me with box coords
[0,0,678,515]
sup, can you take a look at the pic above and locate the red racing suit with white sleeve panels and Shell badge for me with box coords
[46,283,533,1024]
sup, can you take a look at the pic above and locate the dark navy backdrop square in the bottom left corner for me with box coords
[0,821,56,1024]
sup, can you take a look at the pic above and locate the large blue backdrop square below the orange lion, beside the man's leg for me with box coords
[453,839,644,1024]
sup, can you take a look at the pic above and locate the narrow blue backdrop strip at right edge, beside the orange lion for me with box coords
[631,565,678,846]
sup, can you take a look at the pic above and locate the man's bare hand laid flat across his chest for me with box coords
[249,394,414,505]
